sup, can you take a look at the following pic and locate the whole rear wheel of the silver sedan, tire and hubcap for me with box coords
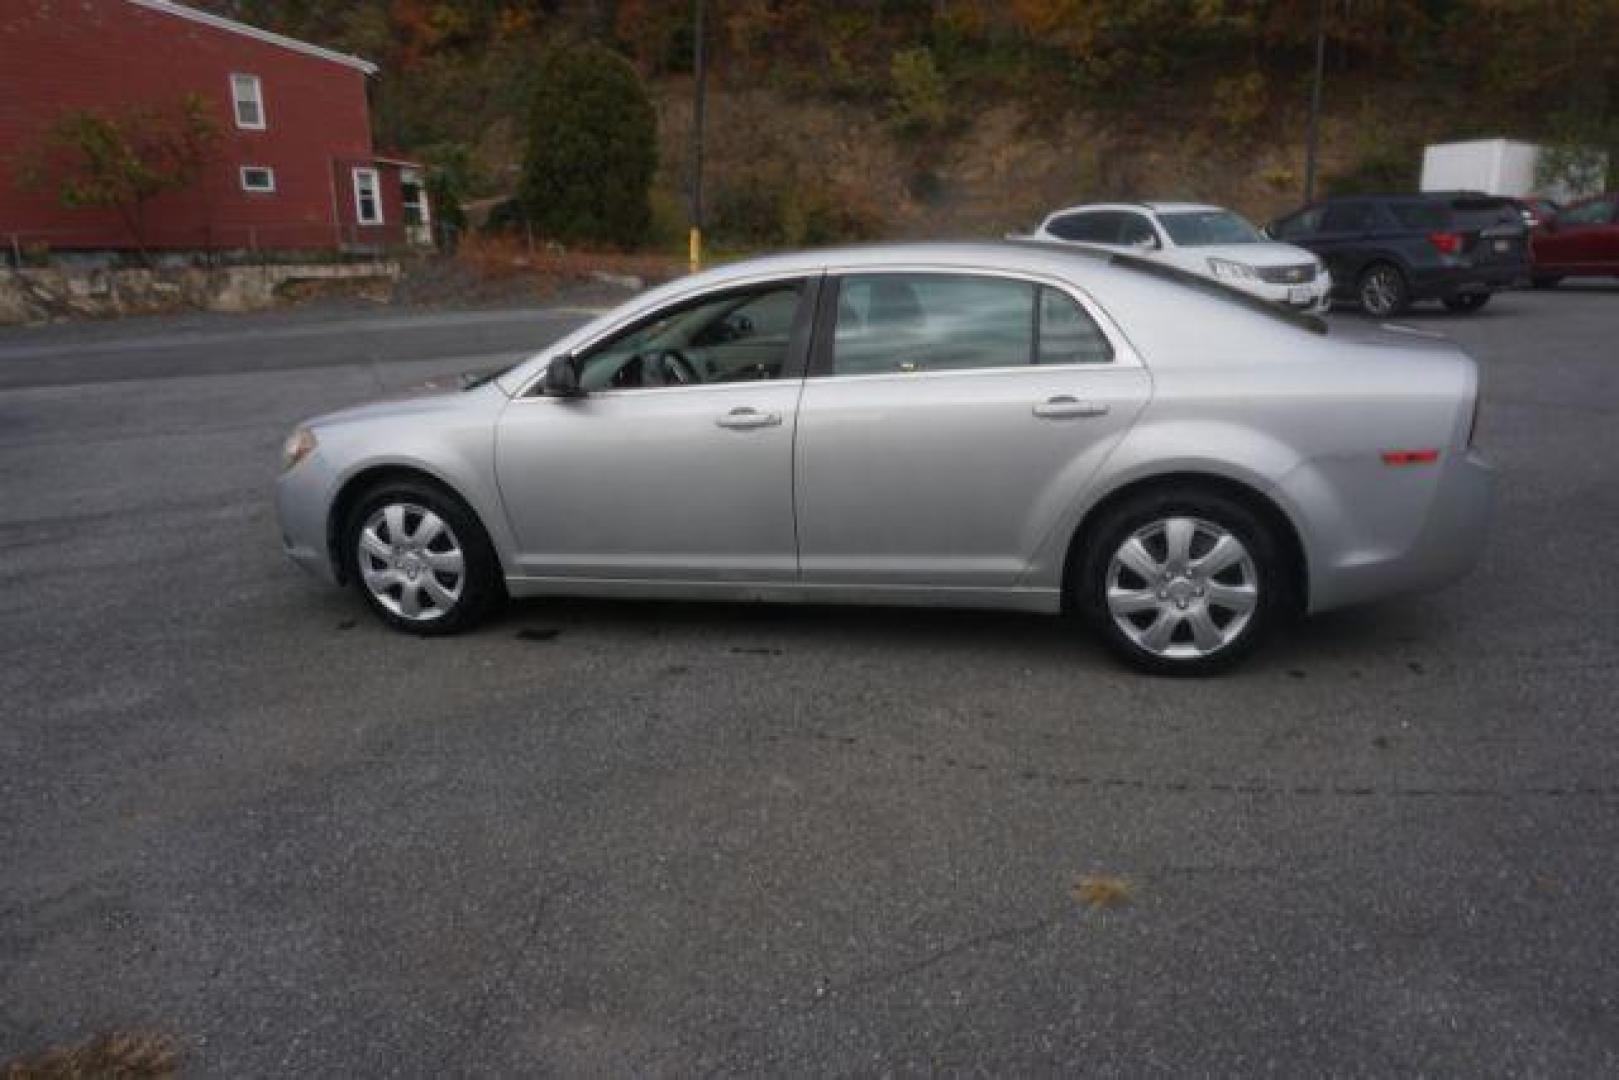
[1077,487,1289,675]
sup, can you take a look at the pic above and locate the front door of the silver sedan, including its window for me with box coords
[495,279,814,581]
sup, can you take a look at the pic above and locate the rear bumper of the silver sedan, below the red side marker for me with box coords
[1310,449,1496,612]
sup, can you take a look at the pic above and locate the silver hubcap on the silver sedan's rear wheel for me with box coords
[1107,518,1260,659]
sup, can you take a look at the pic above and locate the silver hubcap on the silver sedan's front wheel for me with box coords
[359,502,466,622]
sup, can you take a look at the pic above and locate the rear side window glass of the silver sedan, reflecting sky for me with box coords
[831,274,1112,376]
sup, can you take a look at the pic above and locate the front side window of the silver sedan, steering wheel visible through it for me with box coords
[578,282,805,390]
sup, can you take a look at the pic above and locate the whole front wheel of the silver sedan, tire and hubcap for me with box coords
[343,481,500,636]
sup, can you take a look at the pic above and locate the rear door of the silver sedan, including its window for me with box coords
[793,269,1151,589]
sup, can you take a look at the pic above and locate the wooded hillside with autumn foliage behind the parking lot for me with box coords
[202,0,1619,248]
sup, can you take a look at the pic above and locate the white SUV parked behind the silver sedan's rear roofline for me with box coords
[1033,202,1332,314]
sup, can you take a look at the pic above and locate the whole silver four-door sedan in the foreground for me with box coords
[277,244,1494,675]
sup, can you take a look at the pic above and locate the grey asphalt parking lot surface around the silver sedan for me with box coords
[0,285,1619,1075]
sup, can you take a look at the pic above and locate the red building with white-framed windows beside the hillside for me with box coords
[0,0,429,249]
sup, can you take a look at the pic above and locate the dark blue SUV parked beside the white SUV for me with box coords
[1266,191,1528,319]
